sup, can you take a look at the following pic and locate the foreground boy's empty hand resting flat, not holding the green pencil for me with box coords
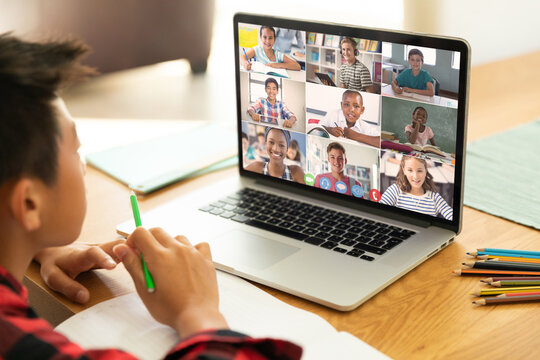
[34,240,124,304]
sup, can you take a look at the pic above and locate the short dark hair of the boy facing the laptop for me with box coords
[0,33,93,185]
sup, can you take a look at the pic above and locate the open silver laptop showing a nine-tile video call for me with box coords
[117,14,470,311]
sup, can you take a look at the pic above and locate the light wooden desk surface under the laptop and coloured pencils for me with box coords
[26,52,540,359]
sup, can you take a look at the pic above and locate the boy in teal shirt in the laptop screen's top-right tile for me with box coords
[392,49,435,96]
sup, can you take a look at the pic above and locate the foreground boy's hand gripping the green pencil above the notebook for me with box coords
[114,227,228,337]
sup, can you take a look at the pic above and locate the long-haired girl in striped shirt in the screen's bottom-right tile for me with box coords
[380,156,453,220]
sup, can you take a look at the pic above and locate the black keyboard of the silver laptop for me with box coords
[199,188,415,261]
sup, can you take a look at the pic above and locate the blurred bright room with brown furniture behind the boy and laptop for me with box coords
[0,0,540,121]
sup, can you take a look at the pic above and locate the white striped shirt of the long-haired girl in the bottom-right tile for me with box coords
[380,184,454,220]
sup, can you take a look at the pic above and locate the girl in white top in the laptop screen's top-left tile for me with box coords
[240,26,301,70]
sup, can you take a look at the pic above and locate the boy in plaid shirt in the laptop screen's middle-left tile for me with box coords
[248,78,296,128]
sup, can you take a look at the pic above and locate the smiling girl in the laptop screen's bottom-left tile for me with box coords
[246,127,304,184]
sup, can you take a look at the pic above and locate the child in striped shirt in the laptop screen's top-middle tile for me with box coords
[338,37,374,92]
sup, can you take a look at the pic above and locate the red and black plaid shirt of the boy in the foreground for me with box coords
[0,267,302,360]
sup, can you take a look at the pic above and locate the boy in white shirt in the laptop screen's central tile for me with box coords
[320,90,380,147]
